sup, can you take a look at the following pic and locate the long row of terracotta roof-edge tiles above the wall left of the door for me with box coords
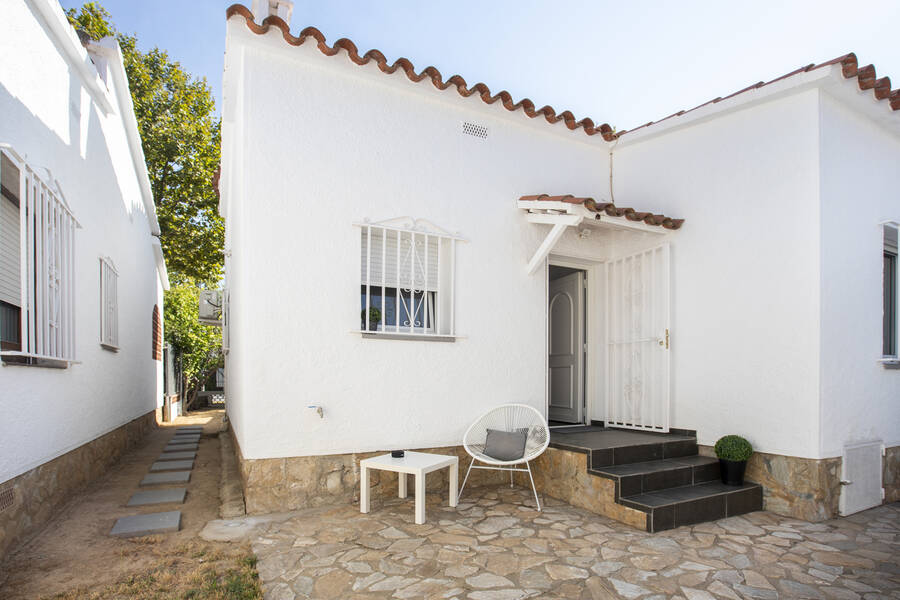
[225,4,616,142]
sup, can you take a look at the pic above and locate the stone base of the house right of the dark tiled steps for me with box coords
[700,446,900,522]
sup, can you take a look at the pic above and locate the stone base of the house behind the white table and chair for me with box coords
[231,429,509,514]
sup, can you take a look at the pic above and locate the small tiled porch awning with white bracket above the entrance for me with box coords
[518,194,684,275]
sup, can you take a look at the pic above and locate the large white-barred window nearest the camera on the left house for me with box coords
[0,146,78,366]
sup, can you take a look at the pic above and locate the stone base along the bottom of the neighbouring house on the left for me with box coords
[0,411,156,558]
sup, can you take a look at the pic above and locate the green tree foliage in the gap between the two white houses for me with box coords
[66,2,225,408]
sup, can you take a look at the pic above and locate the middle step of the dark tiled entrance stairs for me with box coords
[588,456,719,499]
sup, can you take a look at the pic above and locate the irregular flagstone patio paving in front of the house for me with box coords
[237,487,900,600]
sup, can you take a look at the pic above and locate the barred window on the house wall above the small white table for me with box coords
[355,217,464,339]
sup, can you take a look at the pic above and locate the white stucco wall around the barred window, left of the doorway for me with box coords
[223,19,606,458]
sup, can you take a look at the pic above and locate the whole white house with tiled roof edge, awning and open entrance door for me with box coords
[220,0,900,519]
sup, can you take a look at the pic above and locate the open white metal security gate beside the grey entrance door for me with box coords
[606,244,669,431]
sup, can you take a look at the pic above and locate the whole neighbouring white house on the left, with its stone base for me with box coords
[0,0,168,554]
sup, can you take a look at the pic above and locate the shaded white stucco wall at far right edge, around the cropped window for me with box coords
[820,92,900,456]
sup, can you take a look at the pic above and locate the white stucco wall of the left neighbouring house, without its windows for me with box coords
[0,0,162,482]
